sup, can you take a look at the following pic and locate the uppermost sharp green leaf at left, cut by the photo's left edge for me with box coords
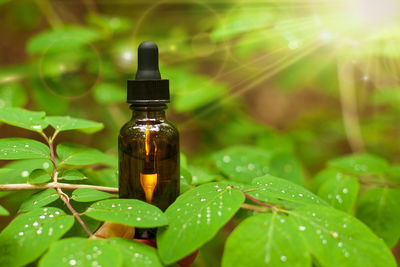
[0,108,48,132]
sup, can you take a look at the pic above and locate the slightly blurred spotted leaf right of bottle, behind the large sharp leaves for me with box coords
[213,146,271,183]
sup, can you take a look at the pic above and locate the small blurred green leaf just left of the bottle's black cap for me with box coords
[93,83,126,104]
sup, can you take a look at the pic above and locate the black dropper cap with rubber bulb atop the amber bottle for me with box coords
[127,41,169,105]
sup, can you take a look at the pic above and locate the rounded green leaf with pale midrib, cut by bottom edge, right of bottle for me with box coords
[222,213,311,267]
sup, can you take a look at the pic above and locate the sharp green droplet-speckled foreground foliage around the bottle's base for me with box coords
[0,109,400,266]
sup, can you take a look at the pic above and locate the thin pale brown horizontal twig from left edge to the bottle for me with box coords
[0,182,118,194]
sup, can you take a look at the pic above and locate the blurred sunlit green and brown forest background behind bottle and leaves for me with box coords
[0,0,400,266]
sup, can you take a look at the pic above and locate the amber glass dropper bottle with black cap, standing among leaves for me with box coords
[118,41,179,239]
